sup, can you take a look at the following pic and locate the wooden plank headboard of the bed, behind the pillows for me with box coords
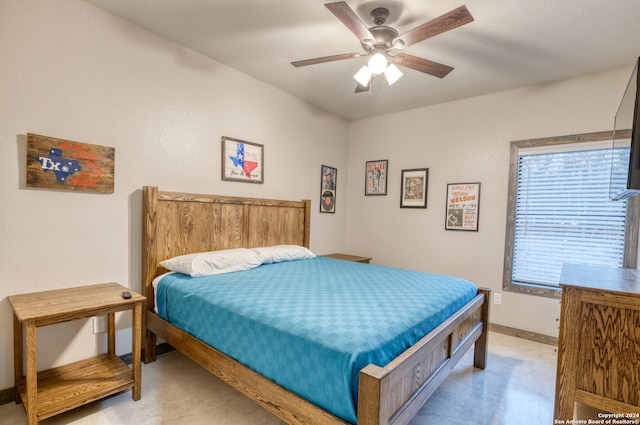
[142,186,311,309]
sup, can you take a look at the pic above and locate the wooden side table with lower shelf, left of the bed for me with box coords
[8,283,145,425]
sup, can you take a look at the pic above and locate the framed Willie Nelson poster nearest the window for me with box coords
[444,183,480,232]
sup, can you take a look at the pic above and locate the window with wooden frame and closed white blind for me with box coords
[503,132,640,297]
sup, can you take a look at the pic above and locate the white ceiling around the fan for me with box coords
[85,0,640,120]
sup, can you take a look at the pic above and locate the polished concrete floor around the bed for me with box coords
[0,332,556,425]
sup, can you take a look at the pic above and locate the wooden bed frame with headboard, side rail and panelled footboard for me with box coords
[142,187,490,425]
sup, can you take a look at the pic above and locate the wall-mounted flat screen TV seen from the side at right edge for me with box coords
[611,58,640,200]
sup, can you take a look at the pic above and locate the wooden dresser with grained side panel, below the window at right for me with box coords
[554,265,640,423]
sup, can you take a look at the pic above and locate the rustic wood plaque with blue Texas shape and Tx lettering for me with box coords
[27,133,115,193]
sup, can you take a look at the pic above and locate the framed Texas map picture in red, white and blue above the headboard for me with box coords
[222,136,264,183]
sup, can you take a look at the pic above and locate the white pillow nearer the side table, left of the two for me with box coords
[160,248,263,277]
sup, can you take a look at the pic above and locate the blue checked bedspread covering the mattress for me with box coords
[156,257,477,423]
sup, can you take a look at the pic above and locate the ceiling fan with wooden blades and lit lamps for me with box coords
[291,1,473,93]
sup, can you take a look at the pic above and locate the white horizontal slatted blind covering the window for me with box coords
[511,143,629,286]
